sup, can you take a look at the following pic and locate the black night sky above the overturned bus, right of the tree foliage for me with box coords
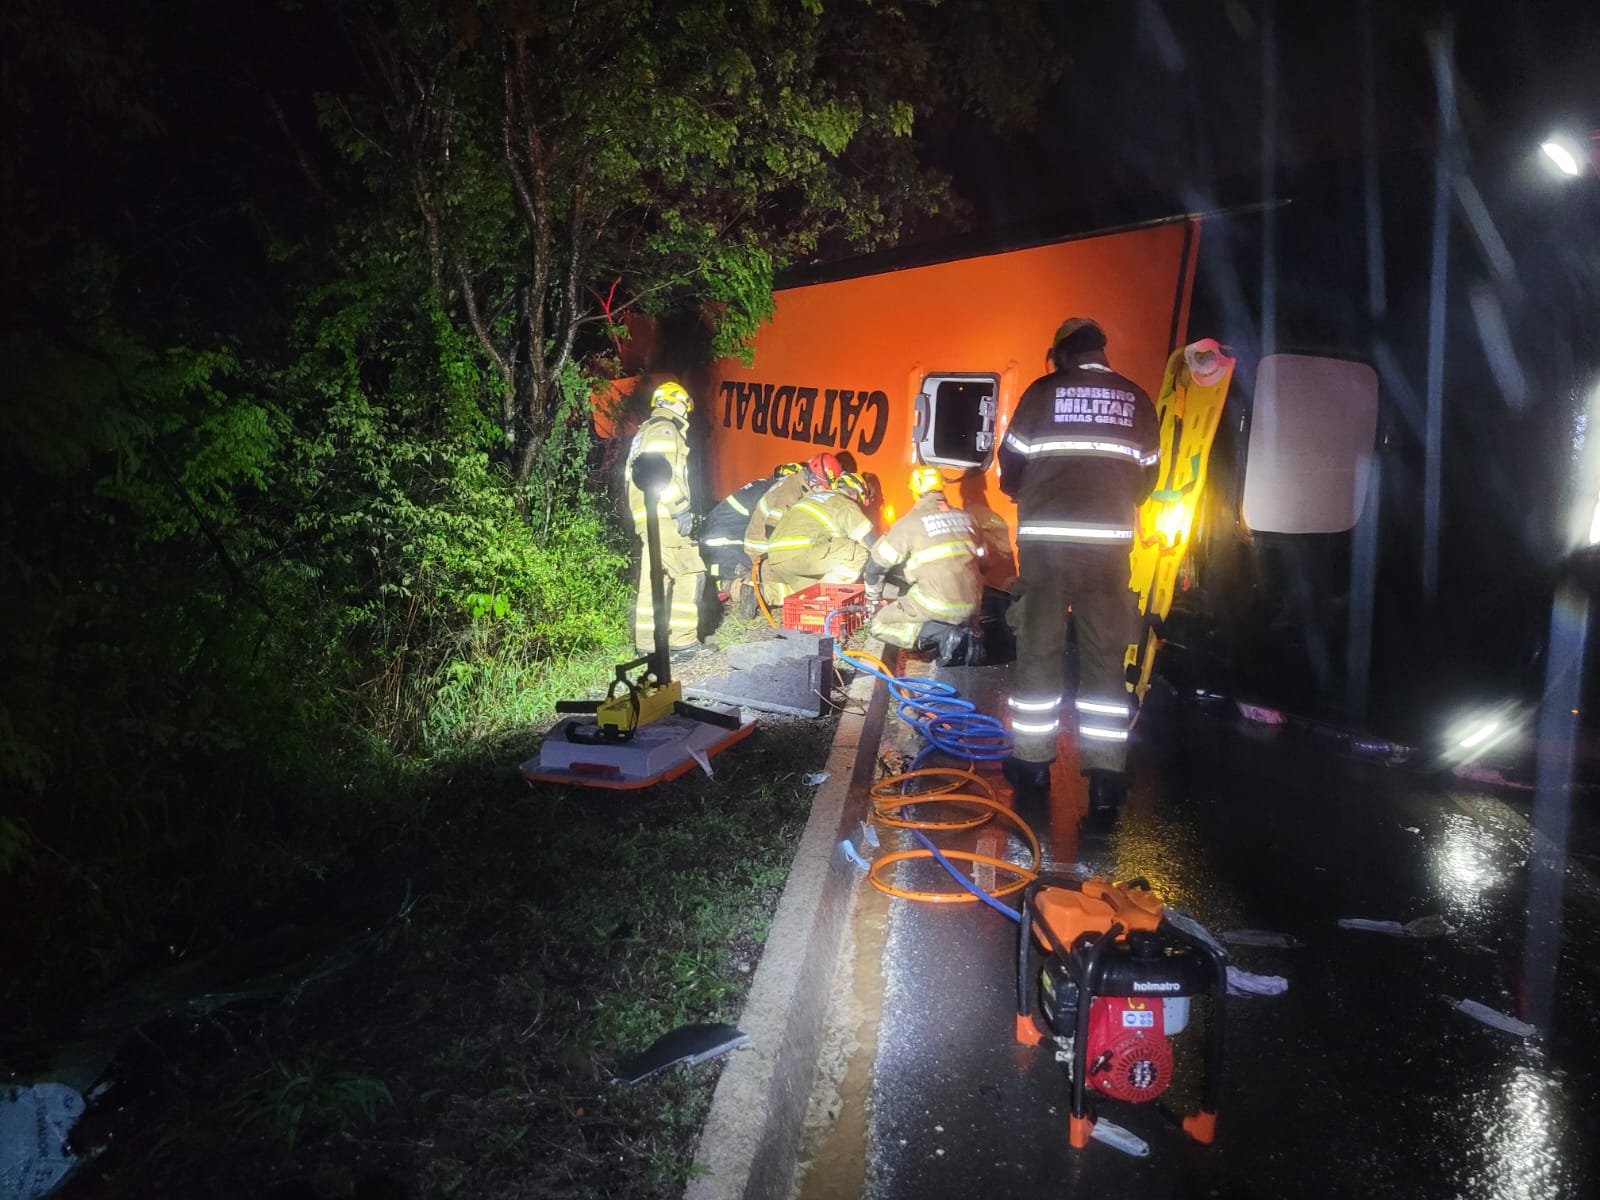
[931,0,1600,236]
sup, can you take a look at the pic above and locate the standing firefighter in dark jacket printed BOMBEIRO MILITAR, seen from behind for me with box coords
[998,317,1160,811]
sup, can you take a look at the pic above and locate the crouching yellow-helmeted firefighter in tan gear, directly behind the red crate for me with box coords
[760,472,872,605]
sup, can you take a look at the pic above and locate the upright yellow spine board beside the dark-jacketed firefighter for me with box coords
[1125,341,1234,702]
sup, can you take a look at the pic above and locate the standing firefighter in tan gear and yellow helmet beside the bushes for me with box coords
[627,381,706,654]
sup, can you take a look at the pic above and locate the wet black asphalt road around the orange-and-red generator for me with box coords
[844,667,1600,1200]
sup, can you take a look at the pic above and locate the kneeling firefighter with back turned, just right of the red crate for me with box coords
[866,467,982,666]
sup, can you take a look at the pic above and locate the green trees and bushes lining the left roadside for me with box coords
[0,0,1045,1022]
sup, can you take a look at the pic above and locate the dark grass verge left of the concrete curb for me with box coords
[67,722,832,1200]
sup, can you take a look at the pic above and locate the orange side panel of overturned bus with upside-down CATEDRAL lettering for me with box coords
[704,218,1198,544]
